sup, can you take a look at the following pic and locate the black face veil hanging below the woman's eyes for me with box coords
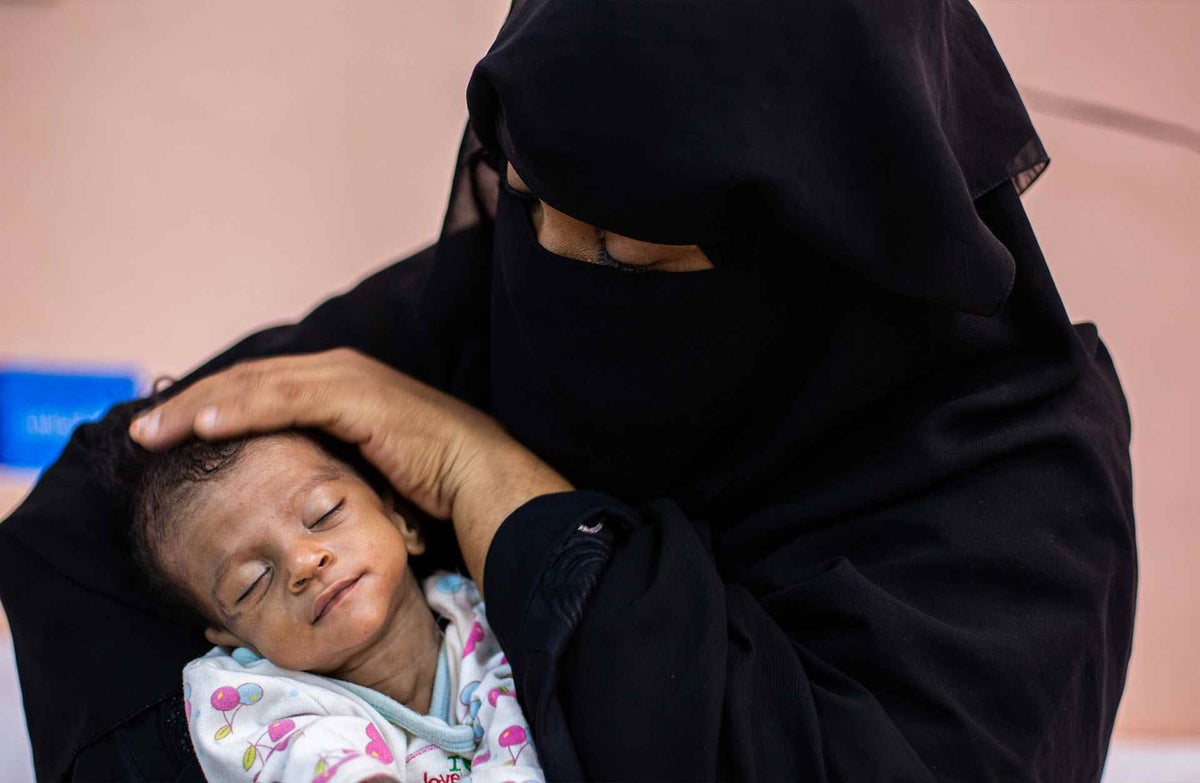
[491,177,788,502]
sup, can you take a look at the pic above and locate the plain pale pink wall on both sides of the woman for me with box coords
[0,0,1200,737]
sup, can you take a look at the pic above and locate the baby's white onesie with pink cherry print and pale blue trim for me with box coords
[184,572,545,783]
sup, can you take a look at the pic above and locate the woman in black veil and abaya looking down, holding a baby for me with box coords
[0,0,1136,782]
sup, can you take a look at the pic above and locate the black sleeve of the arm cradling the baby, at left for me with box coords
[0,228,487,781]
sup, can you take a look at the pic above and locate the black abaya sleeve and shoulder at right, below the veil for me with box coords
[486,177,1135,783]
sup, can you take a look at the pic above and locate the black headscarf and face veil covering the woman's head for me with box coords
[467,0,1048,510]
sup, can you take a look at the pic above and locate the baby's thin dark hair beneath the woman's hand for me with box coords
[106,395,425,627]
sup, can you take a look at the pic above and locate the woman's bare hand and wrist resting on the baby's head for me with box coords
[130,348,574,588]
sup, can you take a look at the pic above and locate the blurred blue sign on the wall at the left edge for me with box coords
[0,366,138,470]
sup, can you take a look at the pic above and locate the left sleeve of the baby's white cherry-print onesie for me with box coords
[184,655,406,783]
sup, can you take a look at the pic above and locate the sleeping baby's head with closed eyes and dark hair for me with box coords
[131,431,431,674]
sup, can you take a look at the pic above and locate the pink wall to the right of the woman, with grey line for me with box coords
[977,0,1200,735]
